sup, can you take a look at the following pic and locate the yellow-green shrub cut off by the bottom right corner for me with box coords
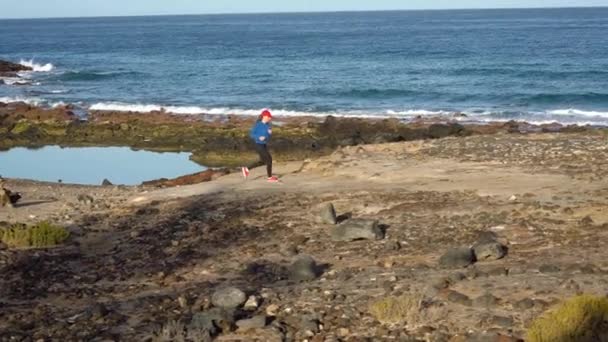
[527,295,608,342]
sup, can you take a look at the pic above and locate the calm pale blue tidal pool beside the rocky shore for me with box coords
[0,146,205,185]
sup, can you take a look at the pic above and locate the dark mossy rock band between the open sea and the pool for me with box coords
[0,102,595,167]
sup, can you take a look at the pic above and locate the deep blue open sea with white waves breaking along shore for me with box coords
[0,8,608,125]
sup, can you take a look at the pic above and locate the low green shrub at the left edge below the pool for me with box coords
[0,222,70,248]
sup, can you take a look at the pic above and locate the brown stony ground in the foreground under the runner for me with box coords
[0,131,608,341]
